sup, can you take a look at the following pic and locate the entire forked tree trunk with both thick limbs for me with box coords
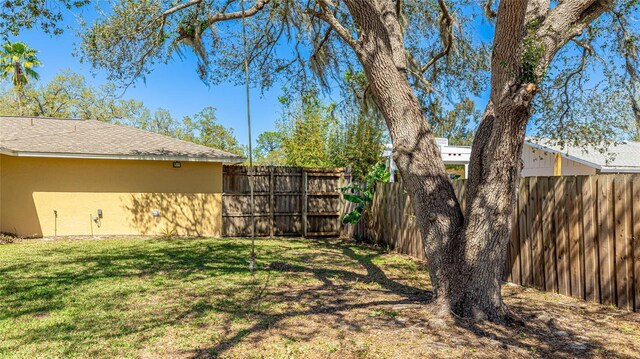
[335,0,607,321]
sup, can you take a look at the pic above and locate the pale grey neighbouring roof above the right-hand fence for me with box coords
[525,138,640,173]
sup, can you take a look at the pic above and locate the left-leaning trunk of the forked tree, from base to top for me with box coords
[347,1,464,313]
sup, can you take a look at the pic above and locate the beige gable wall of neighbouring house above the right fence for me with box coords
[522,144,596,177]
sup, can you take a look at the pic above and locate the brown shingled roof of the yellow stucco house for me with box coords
[0,116,244,163]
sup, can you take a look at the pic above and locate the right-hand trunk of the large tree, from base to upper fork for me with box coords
[448,97,530,321]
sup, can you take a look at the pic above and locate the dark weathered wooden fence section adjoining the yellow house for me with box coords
[222,166,350,237]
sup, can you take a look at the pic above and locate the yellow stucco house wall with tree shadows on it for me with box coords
[0,155,222,237]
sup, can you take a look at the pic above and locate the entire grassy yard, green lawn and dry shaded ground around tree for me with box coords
[0,239,640,359]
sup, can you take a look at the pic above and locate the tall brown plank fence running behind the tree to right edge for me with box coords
[349,175,640,311]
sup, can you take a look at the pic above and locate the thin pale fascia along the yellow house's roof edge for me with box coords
[0,148,246,164]
